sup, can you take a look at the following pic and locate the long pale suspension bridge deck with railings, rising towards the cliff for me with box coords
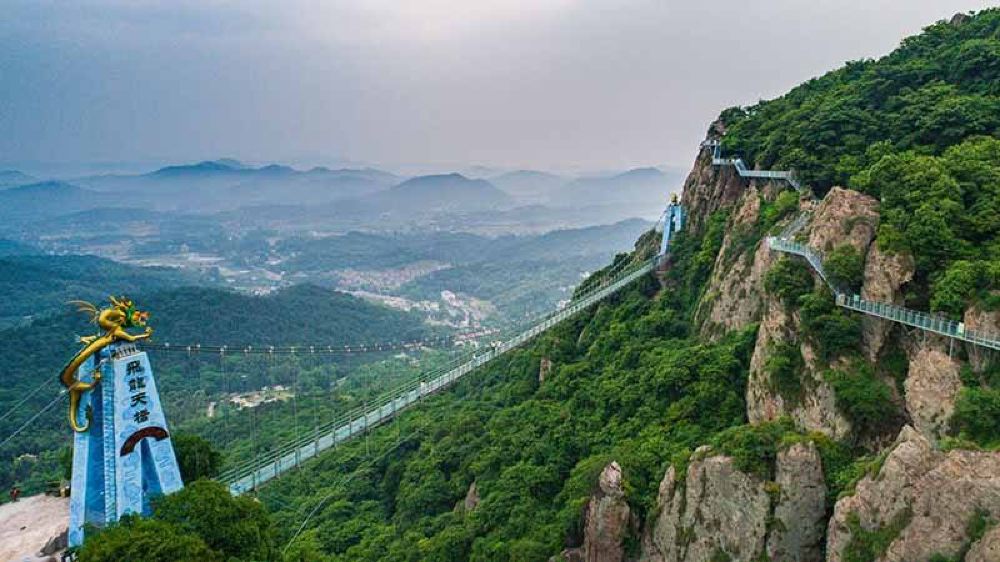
[218,256,659,495]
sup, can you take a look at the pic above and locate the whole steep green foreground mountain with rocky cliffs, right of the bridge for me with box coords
[62,10,1000,562]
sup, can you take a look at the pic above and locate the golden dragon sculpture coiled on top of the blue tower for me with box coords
[59,297,153,431]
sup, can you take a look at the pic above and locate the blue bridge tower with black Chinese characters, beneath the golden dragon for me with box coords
[69,342,183,546]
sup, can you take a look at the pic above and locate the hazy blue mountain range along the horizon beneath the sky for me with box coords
[0,159,680,228]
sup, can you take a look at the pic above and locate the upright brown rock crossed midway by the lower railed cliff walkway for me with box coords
[861,244,915,361]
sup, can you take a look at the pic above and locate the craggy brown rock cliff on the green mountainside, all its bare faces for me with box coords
[567,123,1000,562]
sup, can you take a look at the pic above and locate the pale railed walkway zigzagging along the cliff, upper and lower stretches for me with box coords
[702,140,1000,351]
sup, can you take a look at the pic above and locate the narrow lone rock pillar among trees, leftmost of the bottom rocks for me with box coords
[576,462,631,562]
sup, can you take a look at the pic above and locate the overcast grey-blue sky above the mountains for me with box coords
[0,0,988,172]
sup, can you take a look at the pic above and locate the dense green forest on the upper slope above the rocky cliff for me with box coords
[722,10,1000,315]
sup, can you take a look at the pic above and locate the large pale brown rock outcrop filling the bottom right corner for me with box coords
[827,426,1000,562]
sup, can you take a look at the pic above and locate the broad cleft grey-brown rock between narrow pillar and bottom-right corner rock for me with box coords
[640,443,826,562]
